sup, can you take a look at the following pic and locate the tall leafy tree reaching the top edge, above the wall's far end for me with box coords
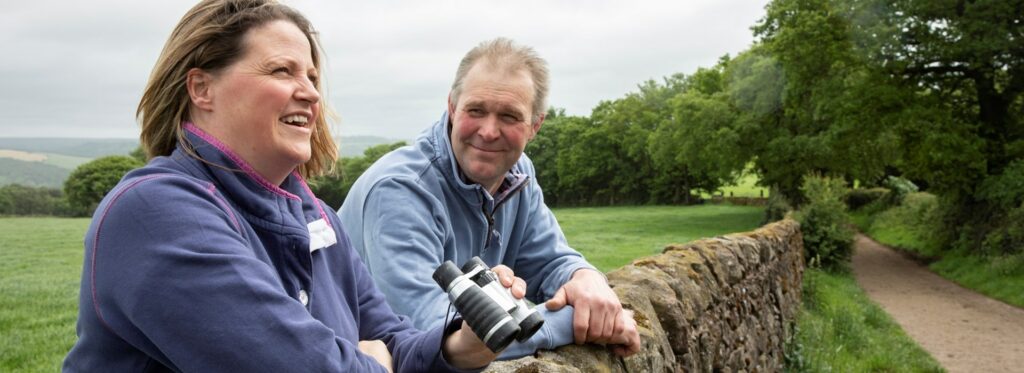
[739,0,901,204]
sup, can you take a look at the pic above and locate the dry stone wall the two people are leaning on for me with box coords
[487,219,804,372]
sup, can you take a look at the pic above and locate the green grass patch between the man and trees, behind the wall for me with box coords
[554,205,764,272]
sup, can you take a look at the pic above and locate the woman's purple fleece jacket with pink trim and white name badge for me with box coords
[63,124,479,372]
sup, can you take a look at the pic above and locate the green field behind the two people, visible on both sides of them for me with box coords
[0,206,761,372]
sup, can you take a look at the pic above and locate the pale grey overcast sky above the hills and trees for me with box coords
[0,0,767,139]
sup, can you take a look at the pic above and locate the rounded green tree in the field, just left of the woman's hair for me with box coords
[63,156,142,215]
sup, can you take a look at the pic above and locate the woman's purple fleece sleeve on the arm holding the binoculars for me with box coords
[331,204,478,372]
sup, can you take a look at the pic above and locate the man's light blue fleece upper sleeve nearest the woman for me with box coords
[362,178,450,330]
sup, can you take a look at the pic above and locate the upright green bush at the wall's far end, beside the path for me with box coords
[795,174,853,270]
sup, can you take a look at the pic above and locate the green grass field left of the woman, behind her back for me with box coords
[0,217,89,372]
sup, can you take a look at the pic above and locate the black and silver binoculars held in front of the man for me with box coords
[433,256,544,354]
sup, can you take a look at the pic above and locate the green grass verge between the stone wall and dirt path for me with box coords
[786,268,943,372]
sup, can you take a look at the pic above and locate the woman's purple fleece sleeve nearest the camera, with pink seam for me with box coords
[89,176,383,372]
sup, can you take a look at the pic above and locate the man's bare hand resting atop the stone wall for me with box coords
[546,270,640,356]
